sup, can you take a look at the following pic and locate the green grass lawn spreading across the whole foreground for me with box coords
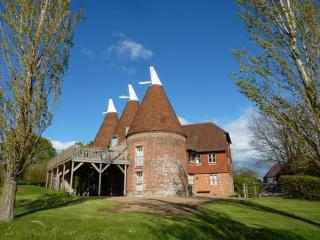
[0,186,320,240]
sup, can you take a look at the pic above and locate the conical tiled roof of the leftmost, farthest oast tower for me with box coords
[92,112,119,148]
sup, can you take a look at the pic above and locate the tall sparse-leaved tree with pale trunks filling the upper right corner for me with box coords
[233,0,320,172]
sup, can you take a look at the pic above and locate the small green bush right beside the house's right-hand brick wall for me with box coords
[233,176,261,197]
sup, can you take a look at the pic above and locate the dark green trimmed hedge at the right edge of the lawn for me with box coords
[279,176,320,200]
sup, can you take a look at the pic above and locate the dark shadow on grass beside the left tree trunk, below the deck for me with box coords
[15,194,92,218]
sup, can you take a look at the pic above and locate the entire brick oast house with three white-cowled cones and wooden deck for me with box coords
[47,67,233,196]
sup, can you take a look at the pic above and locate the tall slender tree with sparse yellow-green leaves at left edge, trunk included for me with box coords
[0,0,82,221]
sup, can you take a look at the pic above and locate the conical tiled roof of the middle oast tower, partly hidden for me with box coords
[114,100,139,143]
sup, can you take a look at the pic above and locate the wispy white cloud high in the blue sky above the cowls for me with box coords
[103,32,153,61]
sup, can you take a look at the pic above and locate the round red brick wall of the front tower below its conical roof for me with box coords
[127,132,187,196]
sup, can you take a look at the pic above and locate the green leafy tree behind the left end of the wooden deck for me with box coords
[21,137,56,185]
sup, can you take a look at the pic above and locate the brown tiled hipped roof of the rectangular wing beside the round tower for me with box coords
[182,123,231,152]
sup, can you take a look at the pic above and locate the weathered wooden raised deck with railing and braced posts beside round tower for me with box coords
[46,145,129,196]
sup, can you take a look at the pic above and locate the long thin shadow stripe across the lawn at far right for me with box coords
[214,199,320,227]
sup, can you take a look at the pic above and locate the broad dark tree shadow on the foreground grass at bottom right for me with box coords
[144,200,303,240]
